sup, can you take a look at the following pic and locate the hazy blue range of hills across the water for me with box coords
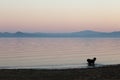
[0,30,120,38]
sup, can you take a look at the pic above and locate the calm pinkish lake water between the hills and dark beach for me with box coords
[0,38,120,68]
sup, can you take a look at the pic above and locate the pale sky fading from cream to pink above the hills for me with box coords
[0,0,120,32]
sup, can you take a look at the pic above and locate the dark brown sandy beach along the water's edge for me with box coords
[0,65,120,80]
